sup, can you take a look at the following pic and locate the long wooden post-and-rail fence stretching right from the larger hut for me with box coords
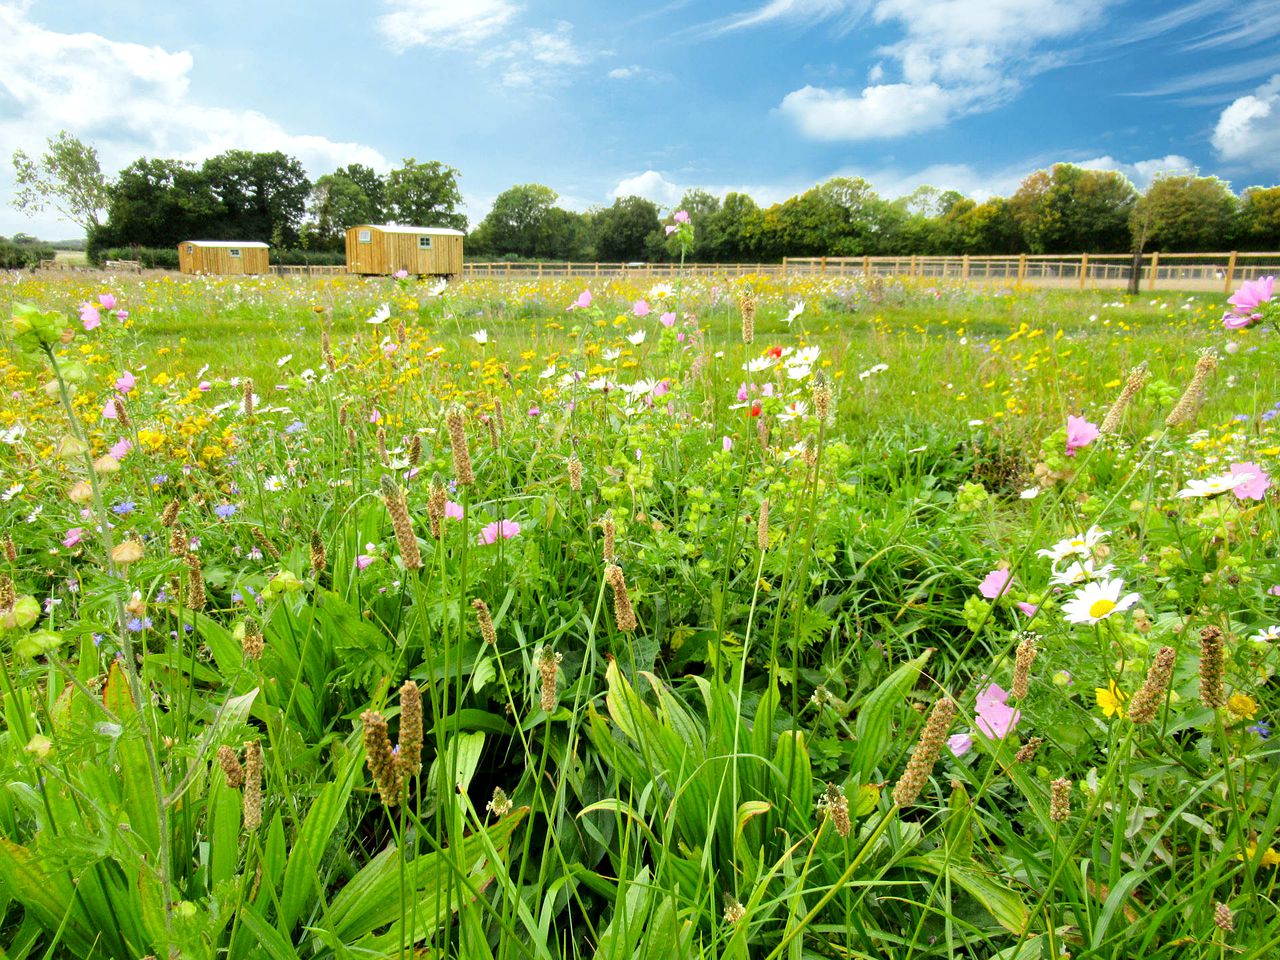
[462,252,1280,292]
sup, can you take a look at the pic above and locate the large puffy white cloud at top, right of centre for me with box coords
[757,0,1111,140]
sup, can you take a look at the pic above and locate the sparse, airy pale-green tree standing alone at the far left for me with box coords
[13,131,109,234]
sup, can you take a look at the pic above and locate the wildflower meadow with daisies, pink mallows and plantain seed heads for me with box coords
[0,257,1280,960]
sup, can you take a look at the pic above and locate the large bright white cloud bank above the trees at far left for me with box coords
[0,4,389,236]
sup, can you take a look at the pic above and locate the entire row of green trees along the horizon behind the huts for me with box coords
[13,132,1280,262]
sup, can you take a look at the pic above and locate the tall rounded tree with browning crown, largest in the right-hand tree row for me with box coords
[1009,164,1138,253]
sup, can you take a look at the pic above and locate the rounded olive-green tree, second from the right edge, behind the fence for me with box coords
[1130,174,1239,252]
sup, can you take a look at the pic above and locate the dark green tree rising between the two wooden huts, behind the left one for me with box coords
[201,150,311,246]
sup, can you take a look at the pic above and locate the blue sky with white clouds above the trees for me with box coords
[0,0,1280,238]
